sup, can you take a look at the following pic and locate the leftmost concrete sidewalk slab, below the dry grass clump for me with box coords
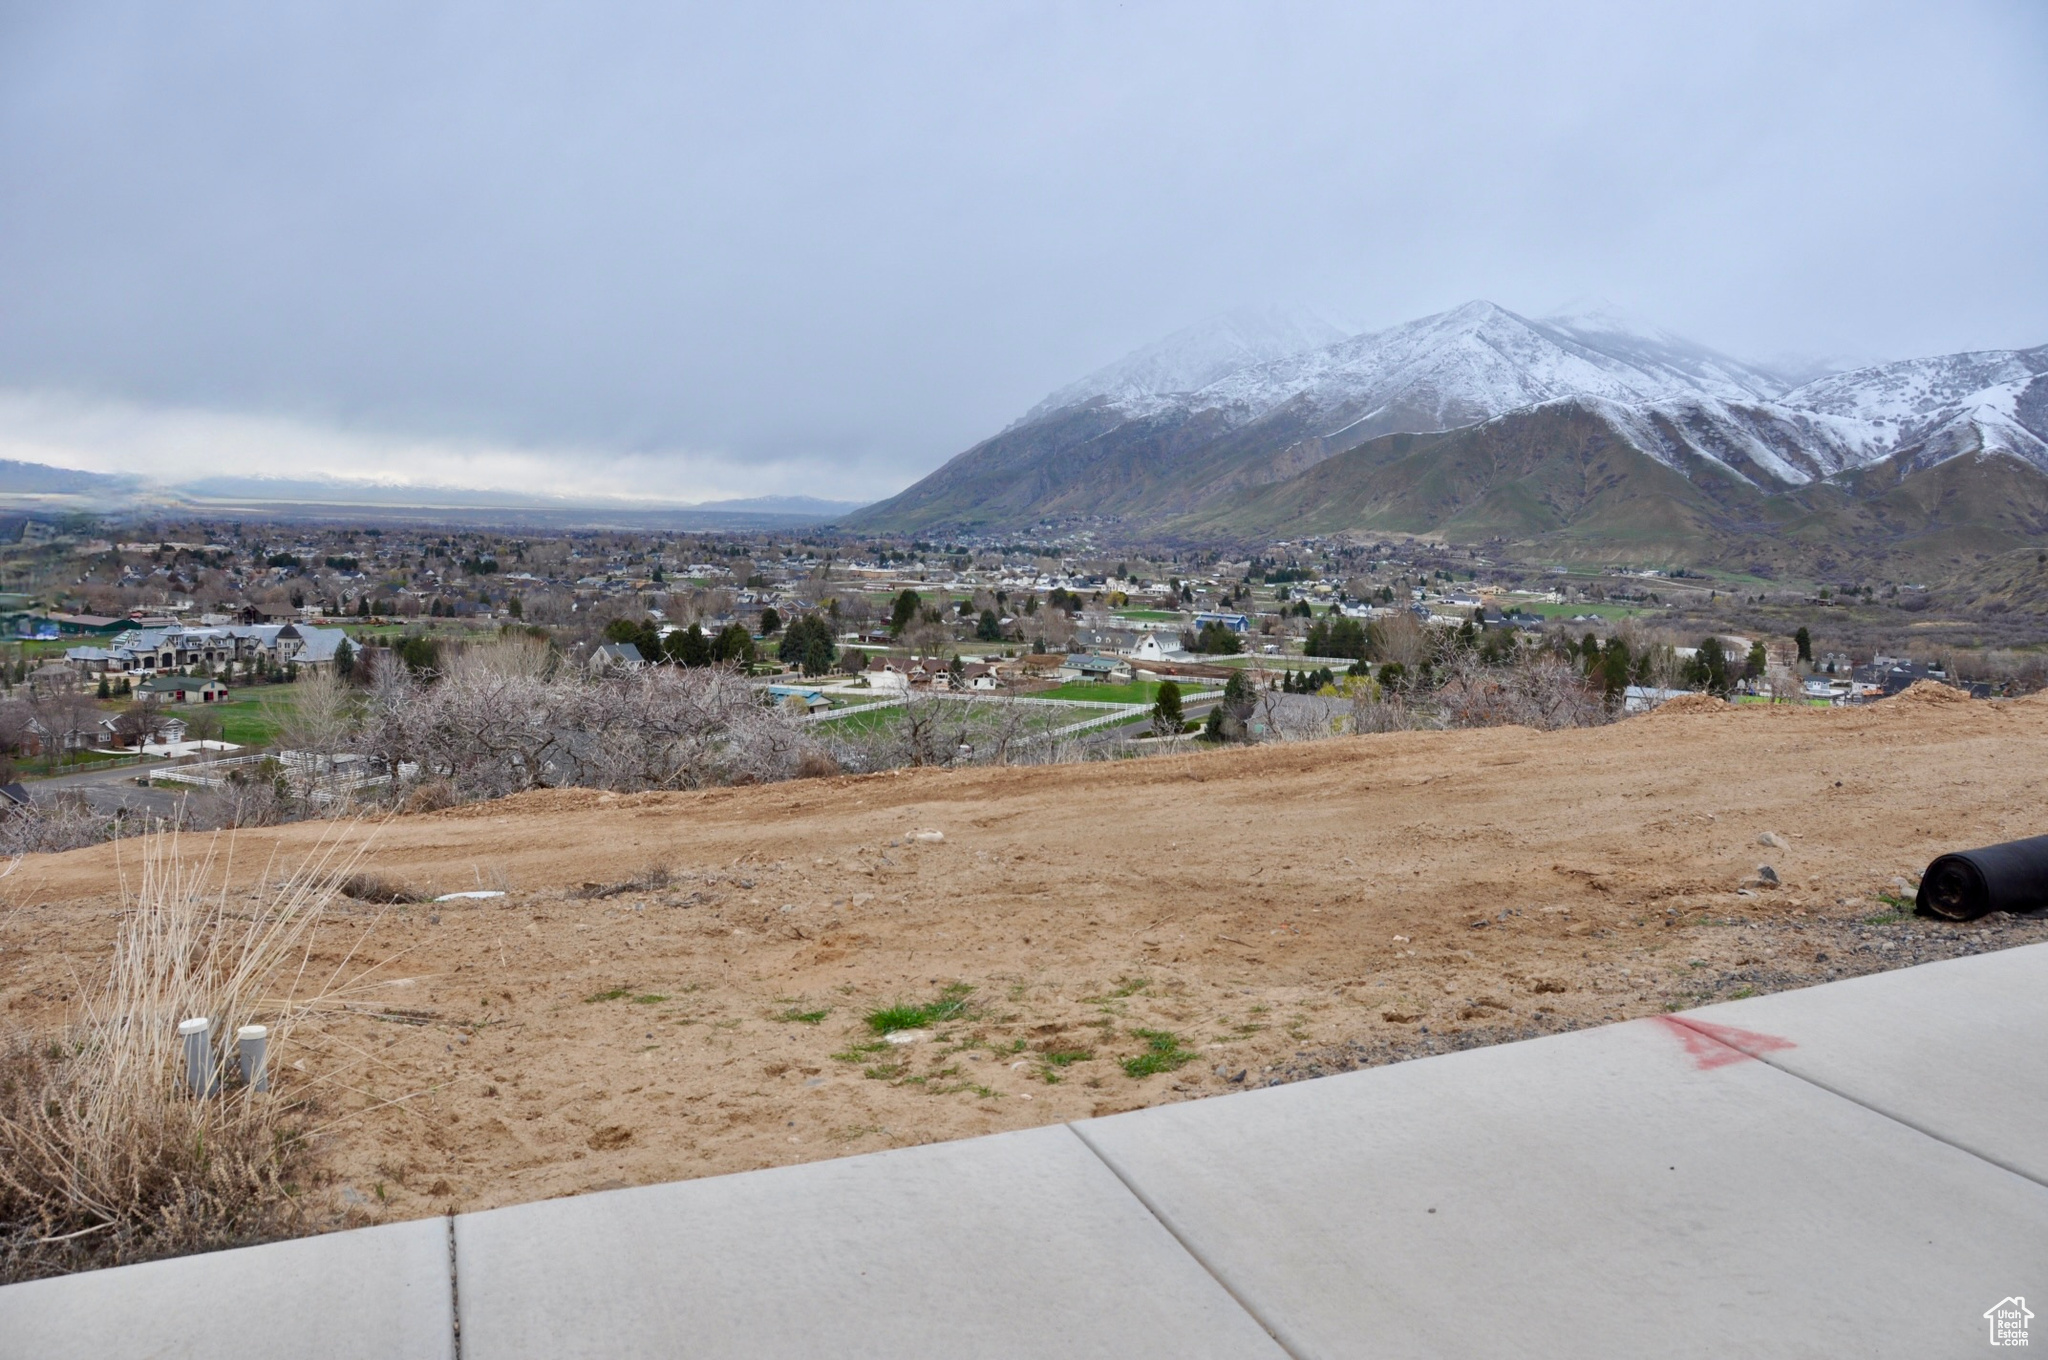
[0,1219,455,1360]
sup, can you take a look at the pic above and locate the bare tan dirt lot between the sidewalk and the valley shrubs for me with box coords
[0,694,2048,1219]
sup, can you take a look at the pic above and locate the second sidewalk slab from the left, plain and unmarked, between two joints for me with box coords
[455,1127,1282,1360]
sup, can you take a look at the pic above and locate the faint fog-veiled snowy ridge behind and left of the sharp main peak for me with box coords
[1012,307,1346,428]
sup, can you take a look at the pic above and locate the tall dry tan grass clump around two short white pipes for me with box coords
[0,836,368,1280]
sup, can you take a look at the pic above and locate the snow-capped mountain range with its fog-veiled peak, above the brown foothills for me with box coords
[848,301,2048,548]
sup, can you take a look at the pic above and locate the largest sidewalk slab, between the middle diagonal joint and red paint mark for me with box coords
[1075,1020,2048,1360]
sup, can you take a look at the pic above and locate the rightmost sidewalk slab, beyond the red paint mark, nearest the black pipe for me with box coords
[1688,944,2048,1187]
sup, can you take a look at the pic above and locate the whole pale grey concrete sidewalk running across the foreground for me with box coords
[0,944,2048,1360]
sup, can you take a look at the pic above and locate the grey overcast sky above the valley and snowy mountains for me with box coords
[0,0,2048,500]
